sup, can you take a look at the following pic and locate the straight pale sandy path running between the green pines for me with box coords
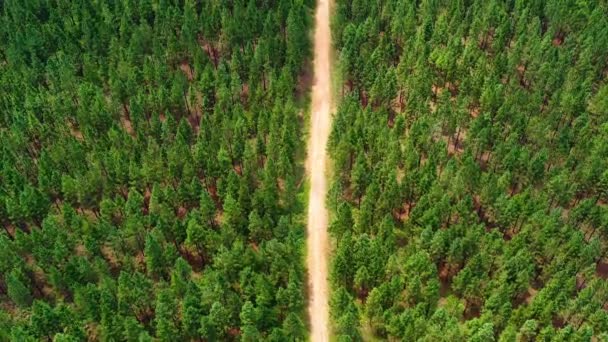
[306,0,332,342]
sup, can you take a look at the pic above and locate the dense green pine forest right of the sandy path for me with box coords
[328,0,608,341]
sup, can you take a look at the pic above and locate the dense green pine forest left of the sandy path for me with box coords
[0,0,313,341]
